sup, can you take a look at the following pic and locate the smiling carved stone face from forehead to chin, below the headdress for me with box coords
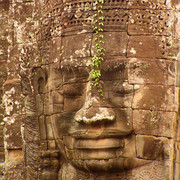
[48,32,176,172]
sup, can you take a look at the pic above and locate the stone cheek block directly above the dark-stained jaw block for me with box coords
[133,110,177,138]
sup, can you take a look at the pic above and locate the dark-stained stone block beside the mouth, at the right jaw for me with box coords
[136,135,173,160]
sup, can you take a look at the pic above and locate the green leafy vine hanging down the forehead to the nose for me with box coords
[90,0,105,101]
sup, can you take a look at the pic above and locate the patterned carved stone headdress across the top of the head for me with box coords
[42,0,168,37]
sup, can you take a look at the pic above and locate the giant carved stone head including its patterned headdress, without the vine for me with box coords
[38,0,178,177]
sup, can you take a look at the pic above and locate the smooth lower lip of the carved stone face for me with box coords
[74,138,124,149]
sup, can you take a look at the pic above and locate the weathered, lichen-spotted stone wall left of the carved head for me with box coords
[0,0,34,180]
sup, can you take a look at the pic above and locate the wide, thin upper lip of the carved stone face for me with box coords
[69,129,132,139]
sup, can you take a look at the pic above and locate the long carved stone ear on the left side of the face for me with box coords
[21,67,50,179]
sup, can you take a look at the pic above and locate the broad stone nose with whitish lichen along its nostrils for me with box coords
[74,83,115,124]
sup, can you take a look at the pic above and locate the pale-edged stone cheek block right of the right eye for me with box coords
[132,85,178,111]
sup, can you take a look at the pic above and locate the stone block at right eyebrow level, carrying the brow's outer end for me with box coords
[127,58,177,85]
